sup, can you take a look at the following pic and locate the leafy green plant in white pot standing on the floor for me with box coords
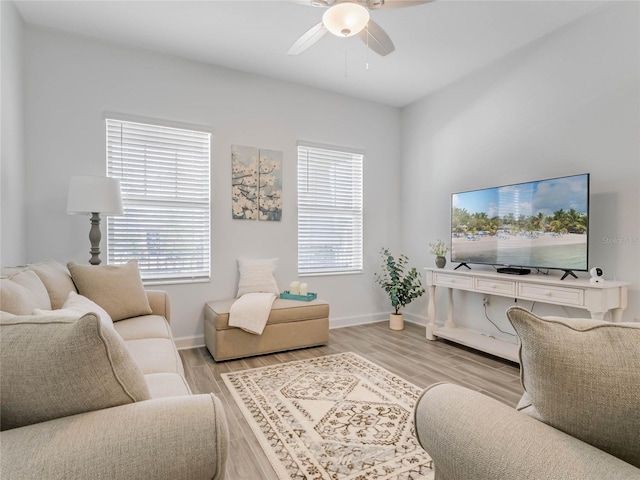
[375,248,424,330]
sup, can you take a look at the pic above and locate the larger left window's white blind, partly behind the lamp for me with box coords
[106,119,211,281]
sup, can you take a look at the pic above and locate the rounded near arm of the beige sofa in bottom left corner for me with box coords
[0,395,228,480]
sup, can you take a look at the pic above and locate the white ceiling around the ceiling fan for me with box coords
[15,0,607,107]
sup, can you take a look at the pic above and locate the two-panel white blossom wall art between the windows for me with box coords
[231,145,282,221]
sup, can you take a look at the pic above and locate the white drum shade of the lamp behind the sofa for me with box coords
[67,176,123,215]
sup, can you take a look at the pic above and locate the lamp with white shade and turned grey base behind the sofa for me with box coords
[67,176,123,265]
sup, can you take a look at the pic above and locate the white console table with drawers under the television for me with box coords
[425,268,628,362]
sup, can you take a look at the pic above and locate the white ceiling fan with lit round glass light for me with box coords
[287,0,433,56]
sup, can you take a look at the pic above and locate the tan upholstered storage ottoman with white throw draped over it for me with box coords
[204,298,329,361]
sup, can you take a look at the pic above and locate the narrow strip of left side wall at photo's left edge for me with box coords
[0,2,27,265]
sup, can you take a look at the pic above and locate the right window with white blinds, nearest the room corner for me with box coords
[298,145,363,275]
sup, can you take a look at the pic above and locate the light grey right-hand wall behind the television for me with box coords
[401,2,640,338]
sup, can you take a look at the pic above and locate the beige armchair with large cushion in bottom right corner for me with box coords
[415,307,640,480]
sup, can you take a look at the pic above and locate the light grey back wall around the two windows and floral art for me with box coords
[20,26,400,345]
